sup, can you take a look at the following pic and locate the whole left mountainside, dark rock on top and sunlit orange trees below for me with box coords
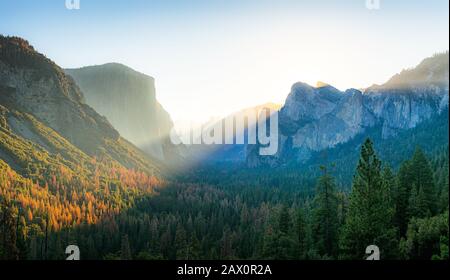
[0,35,165,233]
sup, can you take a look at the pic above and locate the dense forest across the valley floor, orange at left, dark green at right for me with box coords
[0,136,449,260]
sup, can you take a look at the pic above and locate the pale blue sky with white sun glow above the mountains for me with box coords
[0,0,449,126]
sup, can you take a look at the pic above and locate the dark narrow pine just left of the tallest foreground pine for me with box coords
[313,167,339,257]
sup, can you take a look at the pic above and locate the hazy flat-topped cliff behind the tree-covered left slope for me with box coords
[65,63,176,160]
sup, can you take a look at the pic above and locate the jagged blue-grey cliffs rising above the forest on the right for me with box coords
[247,52,449,167]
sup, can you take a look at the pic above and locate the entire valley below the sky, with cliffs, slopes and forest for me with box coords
[0,35,449,260]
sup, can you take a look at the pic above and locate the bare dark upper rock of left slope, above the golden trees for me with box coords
[0,36,120,153]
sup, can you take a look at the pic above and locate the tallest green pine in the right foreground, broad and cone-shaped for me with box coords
[341,139,395,259]
